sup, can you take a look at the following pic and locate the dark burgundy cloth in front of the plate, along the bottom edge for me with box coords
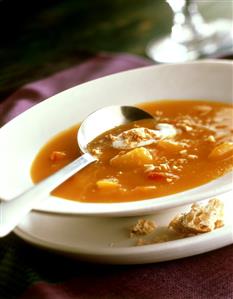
[22,246,233,299]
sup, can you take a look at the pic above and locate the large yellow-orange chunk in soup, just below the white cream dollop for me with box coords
[110,147,153,169]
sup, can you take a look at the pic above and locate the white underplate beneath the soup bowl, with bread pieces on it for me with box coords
[15,193,233,264]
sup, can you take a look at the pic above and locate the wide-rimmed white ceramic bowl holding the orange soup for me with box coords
[0,61,233,216]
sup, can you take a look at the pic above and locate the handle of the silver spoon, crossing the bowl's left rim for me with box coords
[0,153,96,237]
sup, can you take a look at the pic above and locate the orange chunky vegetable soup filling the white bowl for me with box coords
[31,100,233,202]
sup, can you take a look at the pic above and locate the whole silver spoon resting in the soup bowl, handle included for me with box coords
[0,106,152,237]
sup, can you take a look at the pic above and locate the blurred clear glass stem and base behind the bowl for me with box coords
[146,0,233,63]
